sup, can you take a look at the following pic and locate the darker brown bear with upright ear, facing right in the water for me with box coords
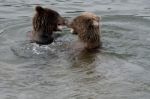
[31,6,66,45]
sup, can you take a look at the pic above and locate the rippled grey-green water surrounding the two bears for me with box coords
[0,0,150,99]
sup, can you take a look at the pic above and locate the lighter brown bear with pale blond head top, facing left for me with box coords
[69,12,101,49]
